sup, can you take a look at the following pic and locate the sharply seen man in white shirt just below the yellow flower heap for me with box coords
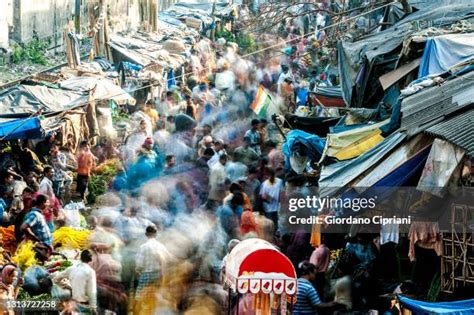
[53,249,97,314]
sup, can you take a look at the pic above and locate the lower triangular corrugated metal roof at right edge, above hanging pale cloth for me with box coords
[426,109,474,157]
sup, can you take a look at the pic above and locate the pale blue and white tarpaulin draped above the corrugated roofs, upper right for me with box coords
[418,33,474,78]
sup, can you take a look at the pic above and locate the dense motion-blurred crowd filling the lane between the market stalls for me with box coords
[0,34,344,314]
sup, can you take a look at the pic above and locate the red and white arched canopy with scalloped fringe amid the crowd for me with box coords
[224,238,297,315]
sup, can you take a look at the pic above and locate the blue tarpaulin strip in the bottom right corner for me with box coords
[399,296,474,315]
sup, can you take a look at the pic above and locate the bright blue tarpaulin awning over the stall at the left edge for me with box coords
[0,117,43,140]
